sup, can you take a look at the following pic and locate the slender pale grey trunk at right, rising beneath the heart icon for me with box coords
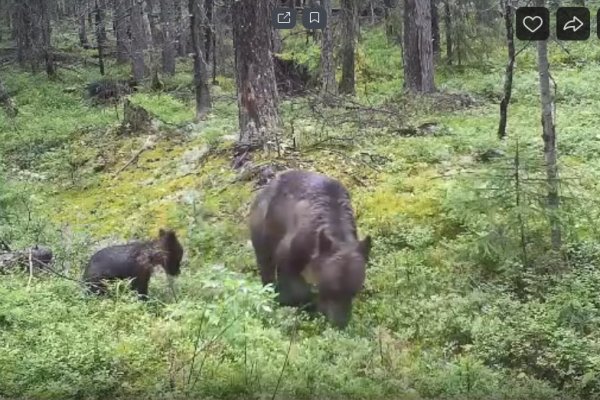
[536,0,562,251]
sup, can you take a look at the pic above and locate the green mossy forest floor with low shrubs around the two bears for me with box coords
[0,29,600,400]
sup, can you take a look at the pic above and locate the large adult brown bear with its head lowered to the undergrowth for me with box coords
[250,170,371,328]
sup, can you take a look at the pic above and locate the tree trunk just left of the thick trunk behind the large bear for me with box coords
[188,0,211,120]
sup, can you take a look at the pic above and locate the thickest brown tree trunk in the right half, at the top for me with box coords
[404,0,435,93]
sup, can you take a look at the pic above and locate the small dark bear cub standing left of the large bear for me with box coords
[83,229,183,299]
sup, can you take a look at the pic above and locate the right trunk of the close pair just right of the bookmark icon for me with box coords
[340,0,359,95]
